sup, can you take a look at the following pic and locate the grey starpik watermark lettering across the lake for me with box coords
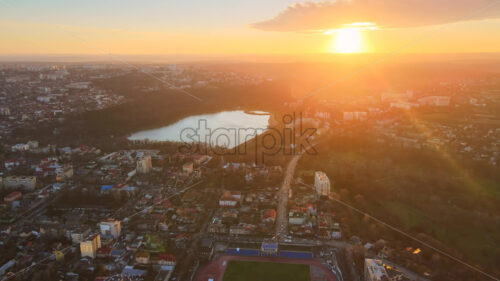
[180,113,318,163]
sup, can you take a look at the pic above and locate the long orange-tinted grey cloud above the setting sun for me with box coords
[251,0,500,32]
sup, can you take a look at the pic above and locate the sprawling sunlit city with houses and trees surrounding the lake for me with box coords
[0,63,500,281]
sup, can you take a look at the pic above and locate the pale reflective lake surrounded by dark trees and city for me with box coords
[128,110,270,148]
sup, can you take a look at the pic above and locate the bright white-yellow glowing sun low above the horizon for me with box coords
[330,28,363,54]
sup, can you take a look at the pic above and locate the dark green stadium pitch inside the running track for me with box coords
[223,260,311,281]
